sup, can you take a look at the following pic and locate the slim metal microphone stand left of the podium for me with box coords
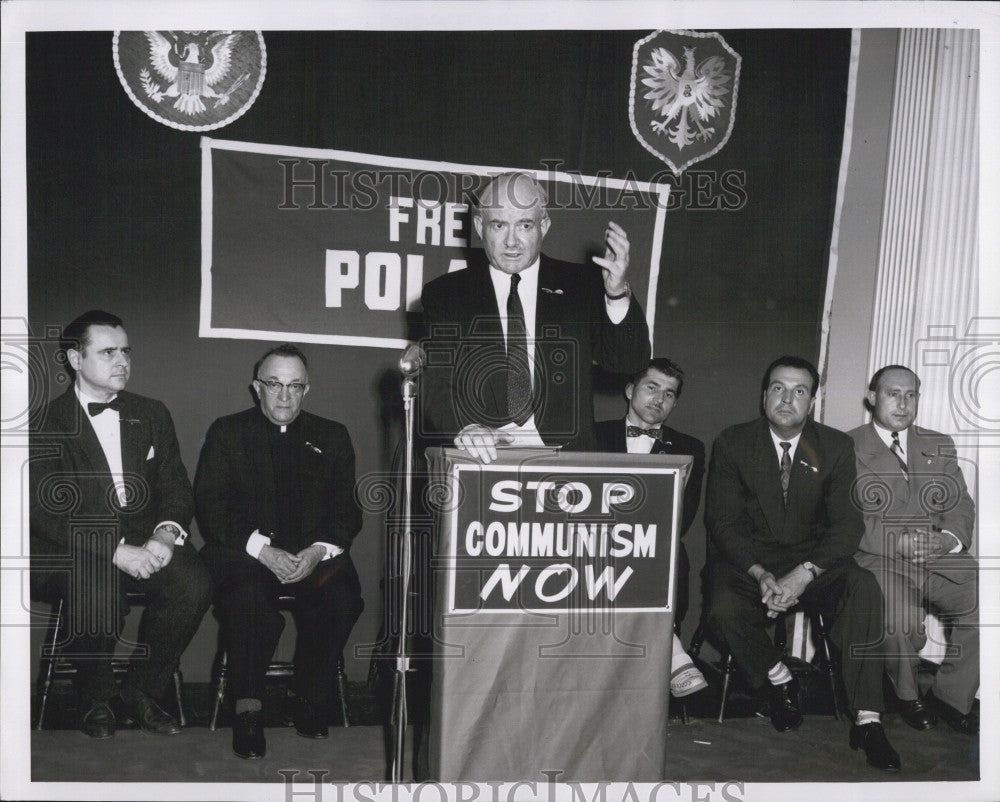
[390,360,417,784]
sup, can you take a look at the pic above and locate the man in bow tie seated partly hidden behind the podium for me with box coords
[594,357,708,697]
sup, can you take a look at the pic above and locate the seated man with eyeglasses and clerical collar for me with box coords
[194,344,364,759]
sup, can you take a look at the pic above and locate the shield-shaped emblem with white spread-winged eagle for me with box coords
[629,31,742,176]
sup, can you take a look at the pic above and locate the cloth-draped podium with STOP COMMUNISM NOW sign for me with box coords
[427,449,691,782]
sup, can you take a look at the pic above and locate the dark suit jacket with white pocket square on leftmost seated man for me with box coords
[30,387,194,580]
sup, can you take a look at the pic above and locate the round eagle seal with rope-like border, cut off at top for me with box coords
[113,31,267,131]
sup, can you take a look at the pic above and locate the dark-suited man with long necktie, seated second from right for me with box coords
[705,356,900,771]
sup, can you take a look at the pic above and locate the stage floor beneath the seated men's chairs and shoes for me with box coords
[23,673,984,784]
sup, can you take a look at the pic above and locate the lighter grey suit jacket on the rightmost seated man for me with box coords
[849,423,976,582]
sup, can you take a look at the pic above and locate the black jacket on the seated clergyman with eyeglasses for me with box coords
[194,407,361,559]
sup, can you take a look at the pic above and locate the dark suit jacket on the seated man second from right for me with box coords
[705,417,864,576]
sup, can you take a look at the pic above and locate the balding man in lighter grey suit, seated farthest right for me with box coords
[849,365,979,735]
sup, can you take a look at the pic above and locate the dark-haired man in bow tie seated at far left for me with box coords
[30,310,211,738]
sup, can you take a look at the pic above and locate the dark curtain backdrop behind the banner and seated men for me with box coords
[25,30,850,680]
